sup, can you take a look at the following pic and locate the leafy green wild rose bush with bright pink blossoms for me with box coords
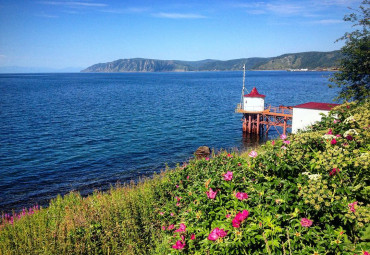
[158,102,370,254]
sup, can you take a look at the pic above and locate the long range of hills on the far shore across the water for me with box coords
[81,51,341,73]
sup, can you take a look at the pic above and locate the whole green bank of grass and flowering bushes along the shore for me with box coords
[0,102,370,254]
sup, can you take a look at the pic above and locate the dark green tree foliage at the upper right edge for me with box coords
[329,0,370,101]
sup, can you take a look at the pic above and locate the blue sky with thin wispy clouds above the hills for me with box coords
[0,0,361,68]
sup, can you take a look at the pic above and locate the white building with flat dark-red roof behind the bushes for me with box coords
[292,102,338,134]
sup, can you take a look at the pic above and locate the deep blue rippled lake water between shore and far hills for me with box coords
[0,71,336,212]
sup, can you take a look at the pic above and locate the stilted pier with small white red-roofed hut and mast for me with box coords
[235,66,293,135]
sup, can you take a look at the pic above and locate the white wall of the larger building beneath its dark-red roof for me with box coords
[292,108,329,134]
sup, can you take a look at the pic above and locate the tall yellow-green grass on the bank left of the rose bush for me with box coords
[0,173,173,254]
